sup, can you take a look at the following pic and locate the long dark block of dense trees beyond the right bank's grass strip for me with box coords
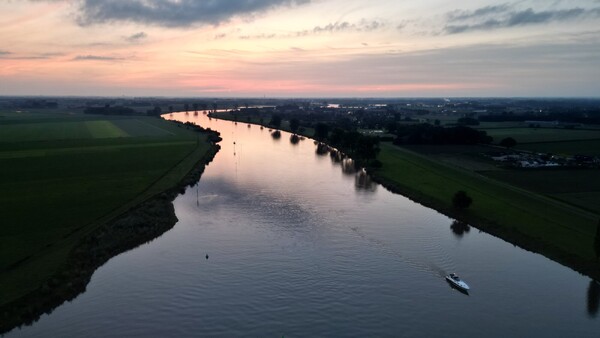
[394,123,493,144]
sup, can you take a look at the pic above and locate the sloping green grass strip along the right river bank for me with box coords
[377,143,598,260]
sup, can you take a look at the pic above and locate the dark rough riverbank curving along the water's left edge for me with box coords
[0,118,220,333]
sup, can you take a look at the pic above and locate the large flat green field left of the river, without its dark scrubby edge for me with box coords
[0,113,210,305]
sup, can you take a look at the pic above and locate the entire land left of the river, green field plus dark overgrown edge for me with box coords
[0,116,216,332]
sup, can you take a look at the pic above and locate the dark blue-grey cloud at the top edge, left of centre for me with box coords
[78,0,310,27]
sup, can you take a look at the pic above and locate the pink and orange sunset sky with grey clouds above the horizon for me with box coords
[0,0,600,97]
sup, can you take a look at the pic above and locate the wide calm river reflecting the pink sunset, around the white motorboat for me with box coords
[7,114,600,337]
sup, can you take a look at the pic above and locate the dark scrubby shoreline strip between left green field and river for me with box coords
[0,133,221,336]
